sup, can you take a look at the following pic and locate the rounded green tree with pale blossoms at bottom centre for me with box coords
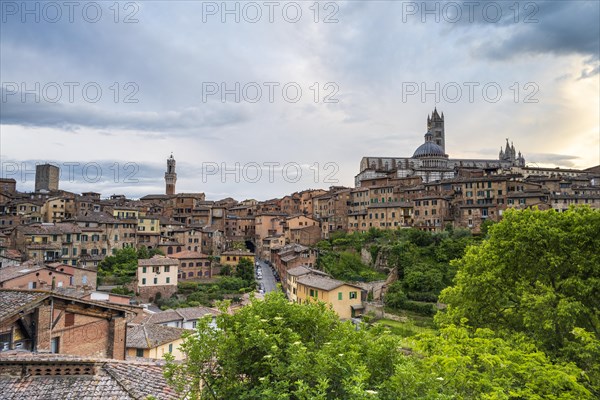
[166,293,402,400]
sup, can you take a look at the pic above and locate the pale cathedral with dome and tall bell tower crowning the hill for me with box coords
[355,108,525,187]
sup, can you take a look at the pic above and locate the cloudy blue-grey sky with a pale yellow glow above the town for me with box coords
[0,0,600,200]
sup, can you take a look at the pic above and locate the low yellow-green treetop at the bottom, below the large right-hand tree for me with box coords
[404,325,593,400]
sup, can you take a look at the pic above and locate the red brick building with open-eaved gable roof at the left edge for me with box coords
[0,289,128,360]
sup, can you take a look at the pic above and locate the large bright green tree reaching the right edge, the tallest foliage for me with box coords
[436,207,600,396]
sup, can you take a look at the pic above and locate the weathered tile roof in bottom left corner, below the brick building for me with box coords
[0,351,178,400]
